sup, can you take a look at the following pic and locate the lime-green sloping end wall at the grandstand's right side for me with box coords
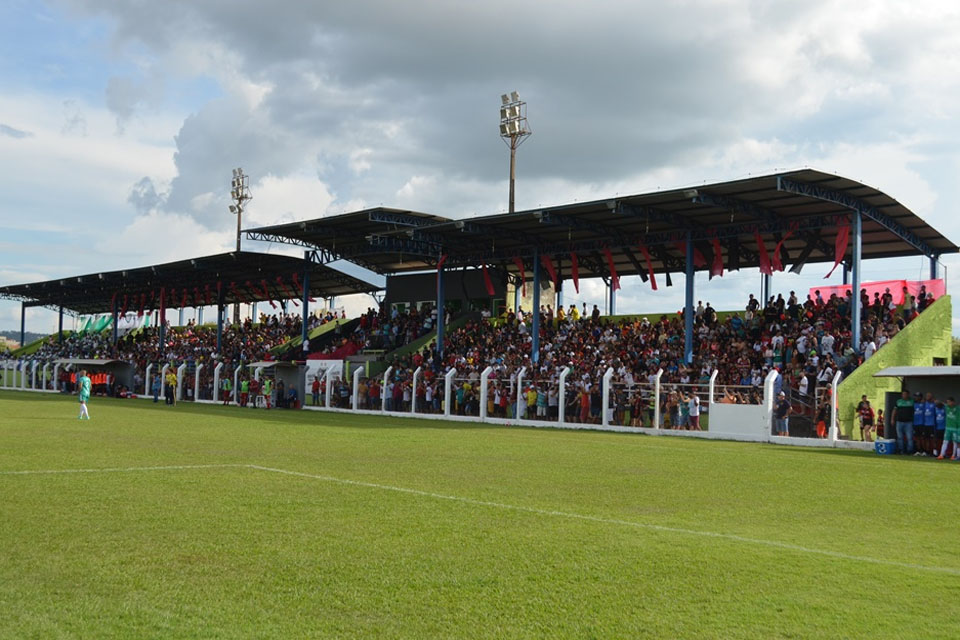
[837,296,953,440]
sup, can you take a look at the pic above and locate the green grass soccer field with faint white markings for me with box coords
[0,392,960,638]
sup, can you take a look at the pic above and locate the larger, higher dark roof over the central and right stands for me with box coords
[246,169,958,278]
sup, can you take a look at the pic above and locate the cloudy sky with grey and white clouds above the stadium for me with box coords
[0,0,960,334]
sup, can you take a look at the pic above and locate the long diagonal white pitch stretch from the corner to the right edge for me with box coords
[247,464,960,576]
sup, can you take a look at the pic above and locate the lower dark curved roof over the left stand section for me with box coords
[0,251,381,314]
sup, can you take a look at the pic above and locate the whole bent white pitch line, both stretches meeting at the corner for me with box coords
[0,463,960,576]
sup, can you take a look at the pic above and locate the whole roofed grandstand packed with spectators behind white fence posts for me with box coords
[0,169,958,446]
